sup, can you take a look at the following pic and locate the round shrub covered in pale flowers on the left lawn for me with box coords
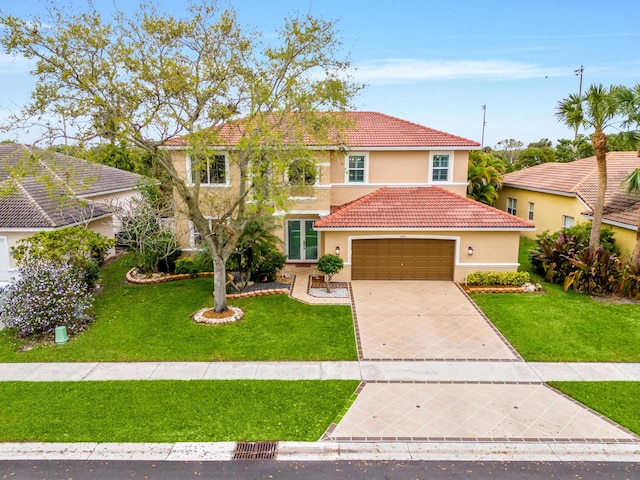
[0,260,93,337]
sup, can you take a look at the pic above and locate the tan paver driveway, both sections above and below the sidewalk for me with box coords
[323,281,640,443]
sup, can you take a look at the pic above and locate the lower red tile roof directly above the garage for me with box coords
[315,187,535,230]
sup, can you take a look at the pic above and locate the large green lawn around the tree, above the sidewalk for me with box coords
[0,260,357,362]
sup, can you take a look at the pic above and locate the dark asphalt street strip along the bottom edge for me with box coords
[0,460,640,480]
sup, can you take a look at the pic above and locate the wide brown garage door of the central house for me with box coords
[351,238,455,280]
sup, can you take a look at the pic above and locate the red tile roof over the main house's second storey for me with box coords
[165,112,480,149]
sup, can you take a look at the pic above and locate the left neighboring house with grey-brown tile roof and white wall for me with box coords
[0,144,142,285]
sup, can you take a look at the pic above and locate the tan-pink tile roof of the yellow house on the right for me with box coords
[504,152,640,226]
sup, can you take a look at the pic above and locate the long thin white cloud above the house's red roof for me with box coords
[352,58,572,84]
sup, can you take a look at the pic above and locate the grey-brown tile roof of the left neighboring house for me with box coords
[0,144,142,228]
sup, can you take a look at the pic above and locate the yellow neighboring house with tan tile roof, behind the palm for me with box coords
[496,152,640,253]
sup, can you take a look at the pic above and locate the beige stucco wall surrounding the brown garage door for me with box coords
[320,230,520,282]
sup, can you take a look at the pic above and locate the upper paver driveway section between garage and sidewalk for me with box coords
[351,280,520,360]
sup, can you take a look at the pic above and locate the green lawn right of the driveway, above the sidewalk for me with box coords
[472,236,640,362]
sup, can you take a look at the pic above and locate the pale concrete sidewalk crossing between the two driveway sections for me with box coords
[0,361,640,383]
